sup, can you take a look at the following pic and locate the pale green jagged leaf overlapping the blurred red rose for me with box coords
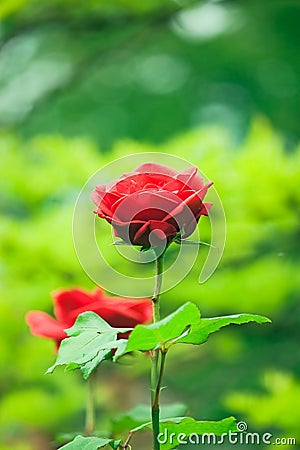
[46,312,131,379]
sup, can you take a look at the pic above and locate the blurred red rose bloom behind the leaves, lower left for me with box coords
[26,288,152,349]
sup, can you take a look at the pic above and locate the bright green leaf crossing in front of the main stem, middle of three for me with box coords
[126,302,200,352]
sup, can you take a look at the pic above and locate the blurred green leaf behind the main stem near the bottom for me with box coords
[112,403,187,433]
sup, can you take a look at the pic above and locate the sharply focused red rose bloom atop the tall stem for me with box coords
[92,163,213,248]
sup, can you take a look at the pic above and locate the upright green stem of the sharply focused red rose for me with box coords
[151,253,165,450]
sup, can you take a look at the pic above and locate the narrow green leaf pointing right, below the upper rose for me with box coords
[178,314,271,345]
